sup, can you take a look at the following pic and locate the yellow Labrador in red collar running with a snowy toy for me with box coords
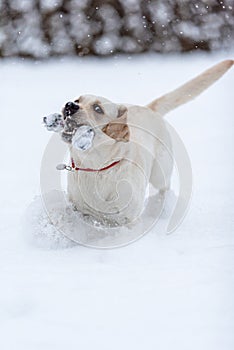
[44,60,234,226]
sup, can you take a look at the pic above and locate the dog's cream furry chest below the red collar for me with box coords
[68,161,147,219]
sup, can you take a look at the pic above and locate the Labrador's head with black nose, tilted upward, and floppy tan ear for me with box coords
[62,95,130,143]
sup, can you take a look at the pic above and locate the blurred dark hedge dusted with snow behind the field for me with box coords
[0,0,234,58]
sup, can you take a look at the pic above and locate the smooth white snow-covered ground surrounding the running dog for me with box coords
[0,54,234,350]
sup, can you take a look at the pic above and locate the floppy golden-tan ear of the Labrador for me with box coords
[102,106,130,142]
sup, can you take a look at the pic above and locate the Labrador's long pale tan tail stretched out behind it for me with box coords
[147,60,234,116]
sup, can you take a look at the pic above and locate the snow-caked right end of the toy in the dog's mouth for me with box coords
[72,125,94,151]
